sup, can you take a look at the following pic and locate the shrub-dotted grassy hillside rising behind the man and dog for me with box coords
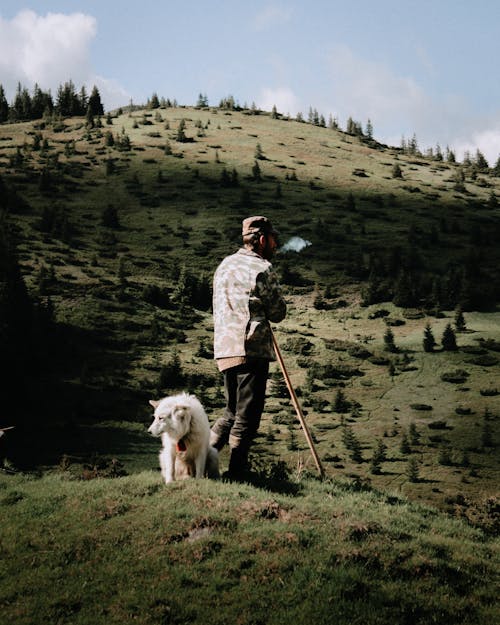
[0,103,500,508]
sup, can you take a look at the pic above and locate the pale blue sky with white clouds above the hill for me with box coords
[0,0,500,166]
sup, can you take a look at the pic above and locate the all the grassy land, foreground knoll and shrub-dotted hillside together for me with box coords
[0,107,500,623]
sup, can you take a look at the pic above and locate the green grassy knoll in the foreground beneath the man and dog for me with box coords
[0,472,498,625]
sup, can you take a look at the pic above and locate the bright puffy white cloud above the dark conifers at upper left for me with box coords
[0,10,129,108]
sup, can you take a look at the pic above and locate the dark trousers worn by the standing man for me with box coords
[212,360,269,454]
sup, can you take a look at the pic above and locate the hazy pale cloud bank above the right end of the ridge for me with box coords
[321,46,500,164]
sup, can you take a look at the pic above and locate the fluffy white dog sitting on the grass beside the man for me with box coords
[149,393,219,483]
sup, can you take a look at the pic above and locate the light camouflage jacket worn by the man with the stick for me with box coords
[213,248,286,360]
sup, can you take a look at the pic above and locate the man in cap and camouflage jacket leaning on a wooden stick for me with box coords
[210,216,286,479]
